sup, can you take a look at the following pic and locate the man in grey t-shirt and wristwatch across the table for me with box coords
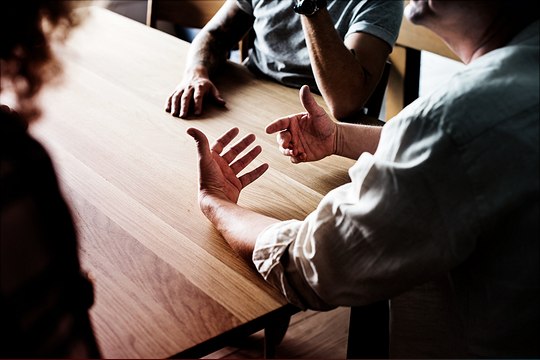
[166,0,403,119]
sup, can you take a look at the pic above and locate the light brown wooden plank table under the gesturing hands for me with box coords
[31,8,352,358]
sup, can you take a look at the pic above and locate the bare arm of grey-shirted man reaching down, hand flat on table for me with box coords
[165,0,253,118]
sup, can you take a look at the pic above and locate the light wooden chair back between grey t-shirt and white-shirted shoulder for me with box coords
[386,9,459,119]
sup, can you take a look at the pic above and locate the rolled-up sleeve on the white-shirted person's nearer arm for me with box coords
[253,104,476,310]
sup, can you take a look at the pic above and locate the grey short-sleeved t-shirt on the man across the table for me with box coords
[236,0,403,89]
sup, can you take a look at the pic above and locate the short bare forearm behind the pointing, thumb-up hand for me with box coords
[334,123,382,159]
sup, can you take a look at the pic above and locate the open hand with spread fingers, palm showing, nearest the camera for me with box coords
[187,128,268,205]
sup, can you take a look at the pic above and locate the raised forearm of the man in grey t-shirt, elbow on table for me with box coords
[301,10,370,119]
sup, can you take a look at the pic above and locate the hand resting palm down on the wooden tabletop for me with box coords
[165,74,225,119]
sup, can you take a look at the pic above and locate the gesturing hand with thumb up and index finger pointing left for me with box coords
[266,85,336,163]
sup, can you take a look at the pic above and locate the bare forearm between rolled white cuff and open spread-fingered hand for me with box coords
[201,196,279,265]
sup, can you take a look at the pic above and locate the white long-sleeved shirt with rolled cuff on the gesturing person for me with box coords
[253,22,540,356]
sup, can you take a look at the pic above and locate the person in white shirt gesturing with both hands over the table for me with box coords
[188,0,540,357]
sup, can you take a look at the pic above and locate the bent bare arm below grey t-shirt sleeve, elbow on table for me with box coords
[301,9,392,119]
